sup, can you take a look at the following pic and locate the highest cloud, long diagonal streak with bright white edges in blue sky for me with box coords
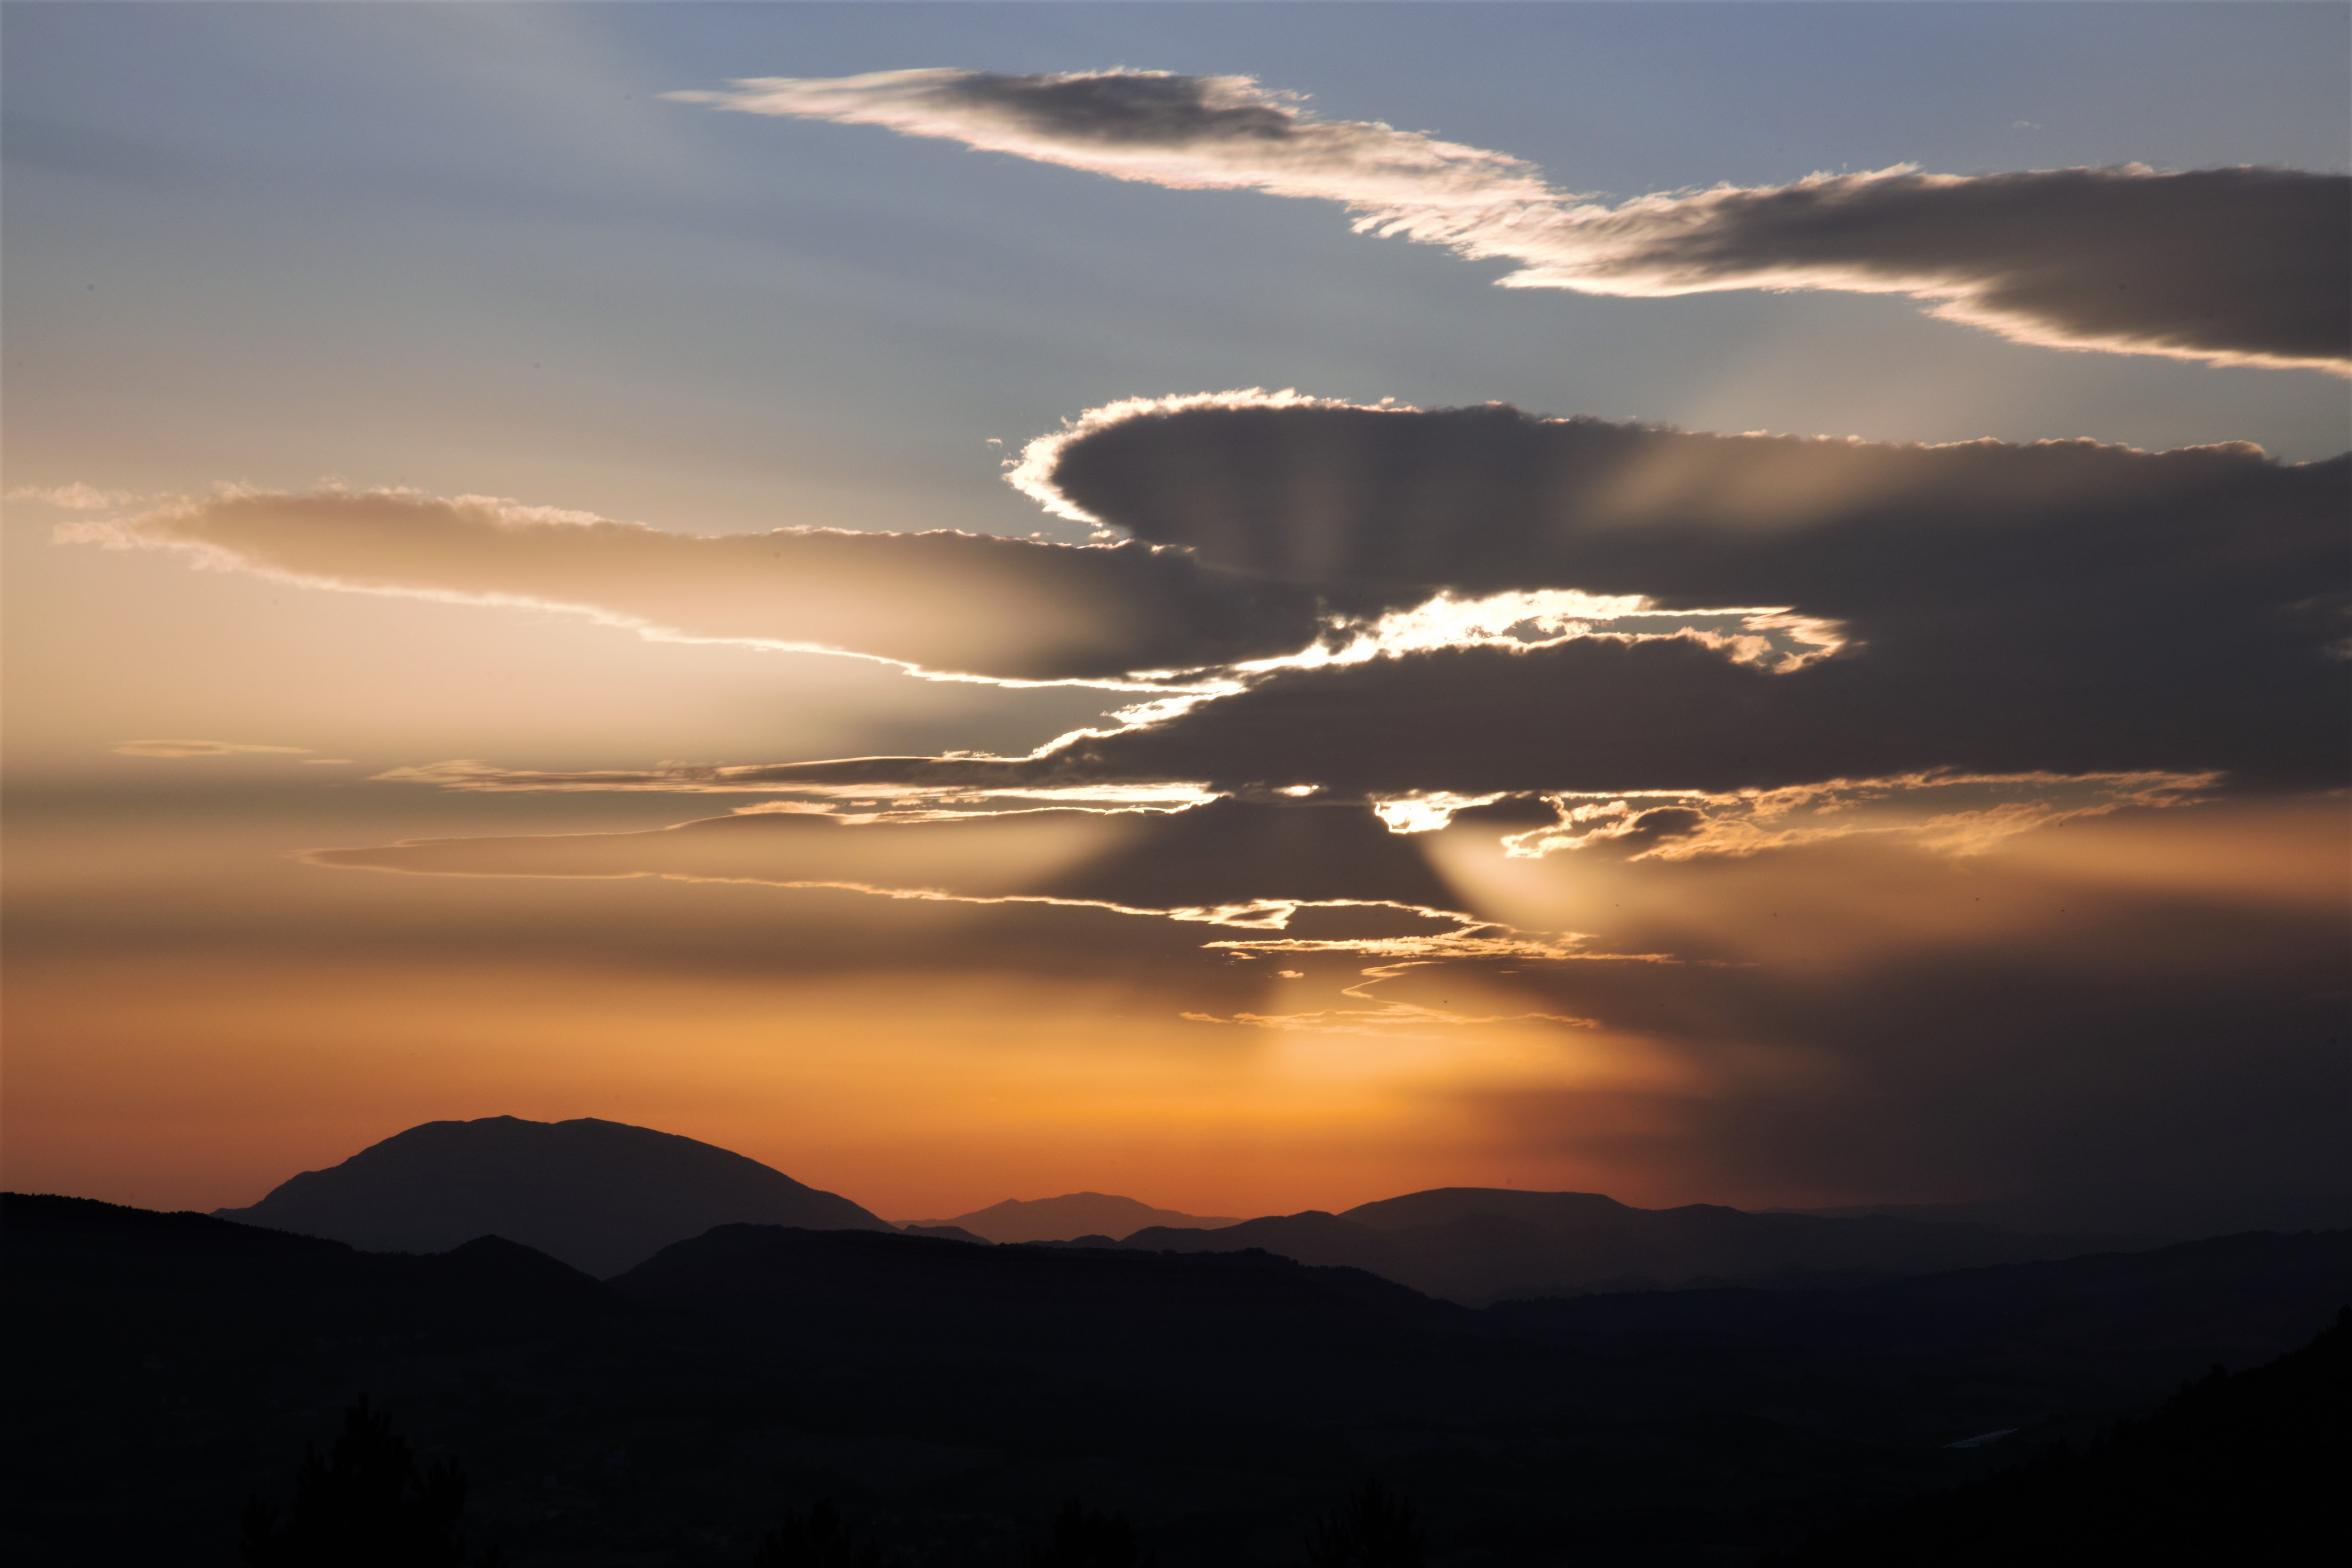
[670,68,2352,374]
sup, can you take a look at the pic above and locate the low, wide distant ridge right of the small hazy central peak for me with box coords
[1124,1187,2131,1305]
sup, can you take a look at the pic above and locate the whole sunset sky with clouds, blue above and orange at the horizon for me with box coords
[0,2,2352,1225]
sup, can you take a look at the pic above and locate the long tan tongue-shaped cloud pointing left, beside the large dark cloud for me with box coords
[59,491,1320,682]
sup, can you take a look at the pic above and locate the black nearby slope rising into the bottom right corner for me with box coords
[1787,1309,2352,1568]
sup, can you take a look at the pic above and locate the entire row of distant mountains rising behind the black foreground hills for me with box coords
[214,1117,2154,1307]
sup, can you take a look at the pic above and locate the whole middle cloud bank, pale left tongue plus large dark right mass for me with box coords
[63,390,2352,804]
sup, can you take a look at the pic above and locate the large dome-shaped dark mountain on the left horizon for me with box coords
[214,1117,891,1277]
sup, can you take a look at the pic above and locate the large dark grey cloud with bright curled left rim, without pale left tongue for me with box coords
[1026,404,2352,792]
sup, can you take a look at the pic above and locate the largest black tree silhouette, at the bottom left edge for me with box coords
[245,1394,504,1568]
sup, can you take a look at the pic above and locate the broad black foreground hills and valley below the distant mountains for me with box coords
[0,1197,2352,1568]
